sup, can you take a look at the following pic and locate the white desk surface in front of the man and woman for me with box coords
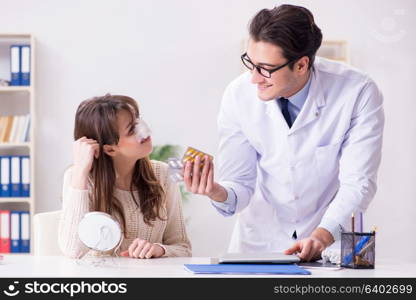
[0,254,416,278]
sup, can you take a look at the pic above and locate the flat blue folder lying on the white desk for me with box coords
[184,264,311,275]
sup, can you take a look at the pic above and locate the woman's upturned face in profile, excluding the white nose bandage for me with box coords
[117,109,153,159]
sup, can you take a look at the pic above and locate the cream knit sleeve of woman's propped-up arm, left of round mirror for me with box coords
[58,169,90,258]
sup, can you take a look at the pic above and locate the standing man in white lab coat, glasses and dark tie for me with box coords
[183,5,384,261]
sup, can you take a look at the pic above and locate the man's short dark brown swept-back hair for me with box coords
[249,4,322,70]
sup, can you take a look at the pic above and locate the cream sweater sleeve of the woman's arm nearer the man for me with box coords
[161,165,192,257]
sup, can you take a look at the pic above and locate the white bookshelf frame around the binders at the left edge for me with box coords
[0,33,36,252]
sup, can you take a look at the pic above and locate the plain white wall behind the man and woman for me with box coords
[0,0,416,261]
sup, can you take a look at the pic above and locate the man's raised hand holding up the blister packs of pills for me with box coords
[182,155,227,202]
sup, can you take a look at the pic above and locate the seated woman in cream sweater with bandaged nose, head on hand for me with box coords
[59,95,191,258]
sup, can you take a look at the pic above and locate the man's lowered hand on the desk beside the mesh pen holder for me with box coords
[284,227,334,261]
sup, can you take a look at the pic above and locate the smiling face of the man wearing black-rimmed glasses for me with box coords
[246,39,303,101]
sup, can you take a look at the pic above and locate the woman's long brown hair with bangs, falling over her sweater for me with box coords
[74,94,164,232]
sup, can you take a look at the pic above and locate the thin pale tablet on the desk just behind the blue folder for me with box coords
[218,252,300,264]
